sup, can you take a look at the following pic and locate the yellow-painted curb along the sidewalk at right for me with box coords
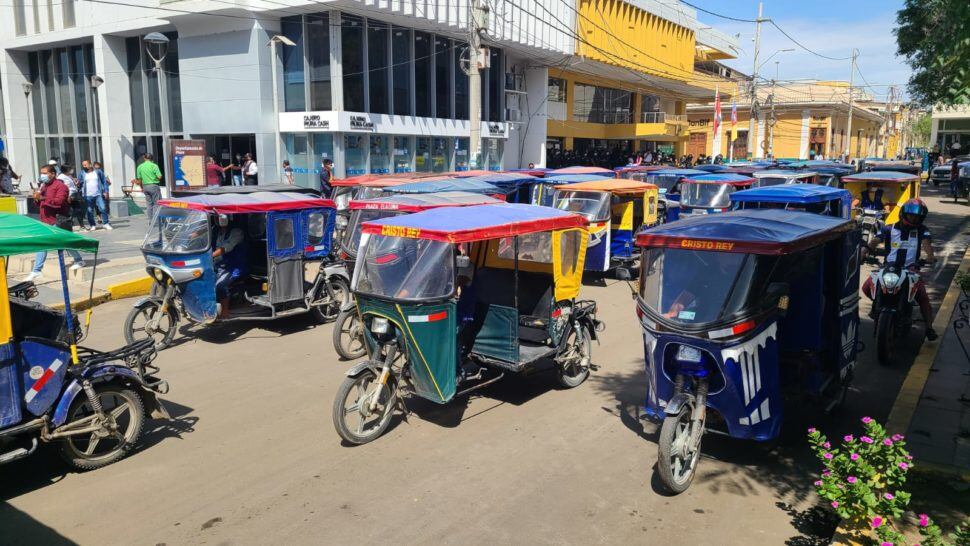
[886,243,970,434]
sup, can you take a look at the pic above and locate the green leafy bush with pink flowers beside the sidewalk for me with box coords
[808,417,970,546]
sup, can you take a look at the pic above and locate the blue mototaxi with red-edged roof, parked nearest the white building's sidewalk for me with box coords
[124,186,350,350]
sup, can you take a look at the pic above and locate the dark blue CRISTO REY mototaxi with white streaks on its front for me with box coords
[636,209,859,493]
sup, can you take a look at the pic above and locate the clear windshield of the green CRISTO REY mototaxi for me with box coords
[353,235,455,300]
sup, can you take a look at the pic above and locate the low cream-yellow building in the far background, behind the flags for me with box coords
[686,82,883,159]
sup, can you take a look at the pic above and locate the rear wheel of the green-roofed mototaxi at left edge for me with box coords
[60,383,145,470]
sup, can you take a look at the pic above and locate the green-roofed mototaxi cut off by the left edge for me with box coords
[0,213,168,470]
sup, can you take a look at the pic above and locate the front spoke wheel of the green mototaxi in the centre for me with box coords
[333,369,397,445]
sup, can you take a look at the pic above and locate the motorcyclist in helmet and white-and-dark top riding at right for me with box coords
[862,199,938,341]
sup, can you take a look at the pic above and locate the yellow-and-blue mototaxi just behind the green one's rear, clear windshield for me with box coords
[553,179,658,279]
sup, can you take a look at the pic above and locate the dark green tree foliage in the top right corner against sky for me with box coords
[893,0,970,105]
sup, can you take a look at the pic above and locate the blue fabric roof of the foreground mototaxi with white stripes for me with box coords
[639,209,855,251]
